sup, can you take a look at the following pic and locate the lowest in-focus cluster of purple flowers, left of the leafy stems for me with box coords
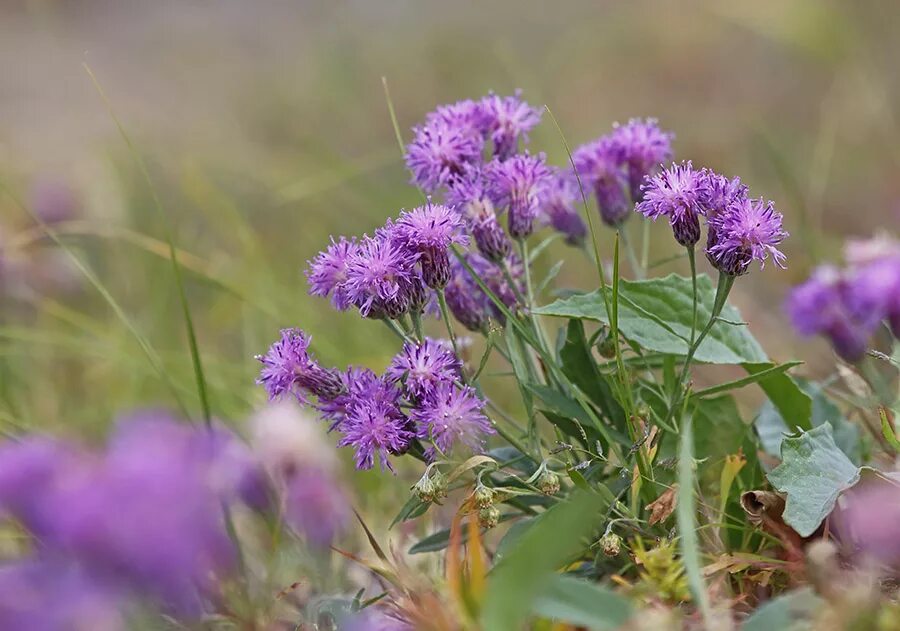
[258,329,494,470]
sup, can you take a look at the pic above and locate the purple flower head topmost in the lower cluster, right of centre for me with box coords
[386,338,462,400]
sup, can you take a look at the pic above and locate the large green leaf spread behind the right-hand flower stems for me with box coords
[535,274,769,364]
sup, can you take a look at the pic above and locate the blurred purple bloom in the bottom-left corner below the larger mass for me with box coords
[0,559,126,631]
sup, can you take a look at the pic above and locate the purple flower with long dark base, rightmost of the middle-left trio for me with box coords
[393,204,469,289]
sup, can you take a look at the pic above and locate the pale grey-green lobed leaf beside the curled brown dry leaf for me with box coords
[767,423,859,537]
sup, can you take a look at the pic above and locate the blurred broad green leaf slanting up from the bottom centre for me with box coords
[481,491,609,631]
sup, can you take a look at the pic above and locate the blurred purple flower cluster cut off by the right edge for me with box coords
[786,236,900,362]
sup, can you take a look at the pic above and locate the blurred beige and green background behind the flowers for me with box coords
[0,0,900,508]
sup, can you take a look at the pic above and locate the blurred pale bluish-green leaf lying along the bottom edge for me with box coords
[533,574,634,631]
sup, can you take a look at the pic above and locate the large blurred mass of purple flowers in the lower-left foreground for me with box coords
[0,412,346,630]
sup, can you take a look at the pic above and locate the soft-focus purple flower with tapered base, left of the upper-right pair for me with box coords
[572,136,630,227]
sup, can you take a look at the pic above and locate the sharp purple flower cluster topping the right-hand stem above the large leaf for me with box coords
[635,161,788,276]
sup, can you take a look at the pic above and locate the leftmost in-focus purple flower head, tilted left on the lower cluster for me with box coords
[256,329,341,403]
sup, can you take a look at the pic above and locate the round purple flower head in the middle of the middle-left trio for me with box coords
[346,235,419,318]
